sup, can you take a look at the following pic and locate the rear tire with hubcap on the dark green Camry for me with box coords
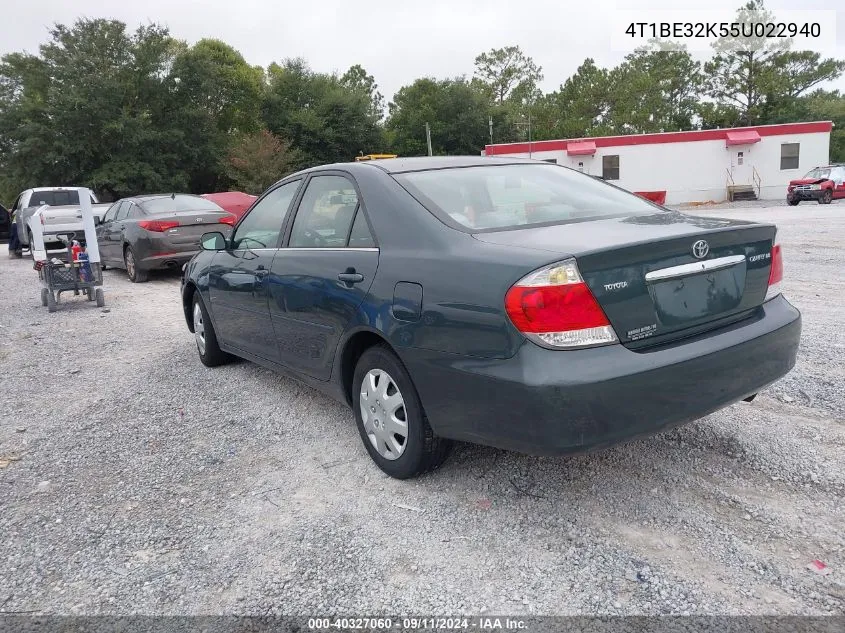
[352,345,452,479]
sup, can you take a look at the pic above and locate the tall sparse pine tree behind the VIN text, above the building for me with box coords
[704,0,845,125]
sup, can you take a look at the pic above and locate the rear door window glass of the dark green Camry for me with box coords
[288,176,358,248]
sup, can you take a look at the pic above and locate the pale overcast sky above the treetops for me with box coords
[0,0,845,100]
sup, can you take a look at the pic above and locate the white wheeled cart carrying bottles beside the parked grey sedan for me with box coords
[27,187,105,312]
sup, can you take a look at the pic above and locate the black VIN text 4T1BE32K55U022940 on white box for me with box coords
[625,22,822,39]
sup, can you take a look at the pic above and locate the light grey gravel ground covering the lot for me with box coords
[0,203,845,615]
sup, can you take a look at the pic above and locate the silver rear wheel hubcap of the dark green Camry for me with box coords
[359,369,408,461]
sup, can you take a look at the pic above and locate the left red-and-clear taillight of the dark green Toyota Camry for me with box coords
[505,259,617,348]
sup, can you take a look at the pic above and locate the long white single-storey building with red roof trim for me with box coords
[484,121,833,204]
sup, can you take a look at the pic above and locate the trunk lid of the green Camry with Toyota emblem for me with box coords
[476,212,775,349]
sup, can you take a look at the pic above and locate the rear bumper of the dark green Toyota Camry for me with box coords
[401,297,801,455]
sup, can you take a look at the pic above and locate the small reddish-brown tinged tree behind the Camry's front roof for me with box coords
[228,130,302,195]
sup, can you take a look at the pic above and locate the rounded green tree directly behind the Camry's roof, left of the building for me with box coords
[386,77,489,156]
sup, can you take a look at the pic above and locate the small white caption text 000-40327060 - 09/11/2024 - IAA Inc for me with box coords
[308,617,528,631]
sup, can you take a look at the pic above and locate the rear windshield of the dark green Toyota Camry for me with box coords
[395,164,656,231]
